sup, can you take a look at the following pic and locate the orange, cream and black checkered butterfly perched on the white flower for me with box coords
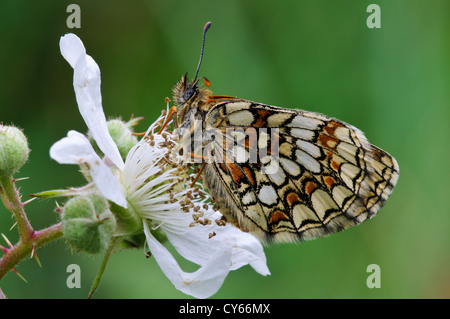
[173,22,399,242]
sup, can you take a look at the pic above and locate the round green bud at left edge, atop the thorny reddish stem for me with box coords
[0,125,30,176]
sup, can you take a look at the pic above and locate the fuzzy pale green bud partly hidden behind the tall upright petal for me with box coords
[89,119,138,160]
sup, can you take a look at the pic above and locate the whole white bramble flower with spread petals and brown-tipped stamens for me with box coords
[50,34,270,298]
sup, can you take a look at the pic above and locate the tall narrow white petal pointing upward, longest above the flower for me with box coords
[60,34,124,170]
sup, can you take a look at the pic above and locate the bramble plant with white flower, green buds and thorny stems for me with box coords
[0,34,269,298]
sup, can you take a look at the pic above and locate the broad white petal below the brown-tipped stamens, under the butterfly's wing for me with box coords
[161,209,270,276]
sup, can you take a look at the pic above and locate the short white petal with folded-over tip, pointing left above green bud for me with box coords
[50,131,127,207]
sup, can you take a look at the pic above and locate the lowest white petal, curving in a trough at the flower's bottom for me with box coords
[143,221,231,298]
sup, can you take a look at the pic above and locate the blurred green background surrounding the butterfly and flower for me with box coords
[0,0,450,298]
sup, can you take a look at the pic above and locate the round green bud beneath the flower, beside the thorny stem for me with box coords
[62,194,116,254]
